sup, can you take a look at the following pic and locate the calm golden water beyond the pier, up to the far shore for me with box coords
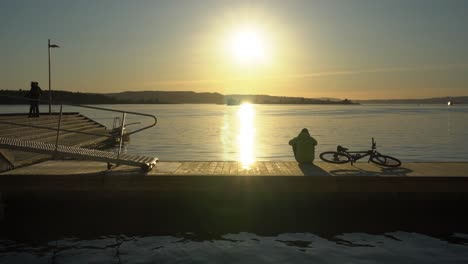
[0,105,468,162]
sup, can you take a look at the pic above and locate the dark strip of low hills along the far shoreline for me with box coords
[0,90,468,106]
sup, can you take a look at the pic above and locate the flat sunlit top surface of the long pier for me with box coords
[0,160,468,177]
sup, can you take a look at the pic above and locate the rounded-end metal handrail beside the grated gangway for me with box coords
[0,94,158,156]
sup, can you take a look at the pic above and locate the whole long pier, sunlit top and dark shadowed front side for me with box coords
[0,161,468,240]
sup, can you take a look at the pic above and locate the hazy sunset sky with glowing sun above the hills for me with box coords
[0,0,468,99]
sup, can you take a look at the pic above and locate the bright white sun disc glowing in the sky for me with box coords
[229,29,266,64]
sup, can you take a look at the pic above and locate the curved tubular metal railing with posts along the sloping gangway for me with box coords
[0,94,158,157]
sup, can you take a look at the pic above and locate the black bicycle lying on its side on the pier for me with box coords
[320,138,401,167]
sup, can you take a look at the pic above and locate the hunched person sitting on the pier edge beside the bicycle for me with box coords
[289,128,317,163]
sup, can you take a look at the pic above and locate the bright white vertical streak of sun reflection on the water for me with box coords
[237,103,255,169]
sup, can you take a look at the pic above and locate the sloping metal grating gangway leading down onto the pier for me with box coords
[0,137,158,171]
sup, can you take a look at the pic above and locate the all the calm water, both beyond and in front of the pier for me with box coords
[0,105,468,263]
